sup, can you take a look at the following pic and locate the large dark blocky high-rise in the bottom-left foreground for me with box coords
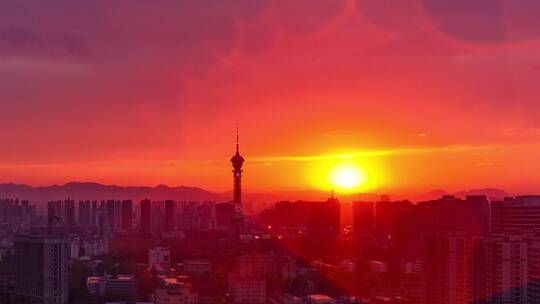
[14,235,68,304]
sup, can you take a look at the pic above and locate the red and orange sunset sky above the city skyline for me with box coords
[0,0,540,193]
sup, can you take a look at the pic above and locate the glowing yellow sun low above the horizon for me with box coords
[329,163,367,191]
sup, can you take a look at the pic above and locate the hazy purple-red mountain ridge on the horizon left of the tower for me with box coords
[0,182,227,202]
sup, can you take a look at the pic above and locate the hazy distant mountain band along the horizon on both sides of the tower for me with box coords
[0,182,511,207]
